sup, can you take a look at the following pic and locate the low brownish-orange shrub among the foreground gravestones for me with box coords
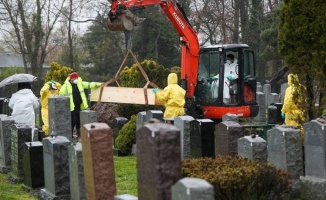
[182,156,291,200]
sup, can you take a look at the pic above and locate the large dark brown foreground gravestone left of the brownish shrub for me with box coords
[136,122,181,200]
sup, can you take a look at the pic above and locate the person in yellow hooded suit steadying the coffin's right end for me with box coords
[153,73,186,118]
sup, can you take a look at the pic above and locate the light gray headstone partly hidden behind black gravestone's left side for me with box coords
[174,116,195,159]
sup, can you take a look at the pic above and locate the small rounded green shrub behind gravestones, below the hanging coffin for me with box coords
[115,115,136,154]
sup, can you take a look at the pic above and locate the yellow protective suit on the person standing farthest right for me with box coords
[281,74,304,126]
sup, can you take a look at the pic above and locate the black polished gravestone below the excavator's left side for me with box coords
[190,119,215,158]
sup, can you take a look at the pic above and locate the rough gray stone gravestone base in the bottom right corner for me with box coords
[300,176,326,200]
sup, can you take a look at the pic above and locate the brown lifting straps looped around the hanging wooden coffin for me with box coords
[98,50,158,105]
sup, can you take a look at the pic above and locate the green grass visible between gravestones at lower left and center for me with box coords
[0,156,137,200]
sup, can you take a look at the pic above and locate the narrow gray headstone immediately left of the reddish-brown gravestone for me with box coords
[68,142,86,200]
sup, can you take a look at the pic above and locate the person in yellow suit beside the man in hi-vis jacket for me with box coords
[40,80,61,135]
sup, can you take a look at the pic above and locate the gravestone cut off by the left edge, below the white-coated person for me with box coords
[0,117,15,173]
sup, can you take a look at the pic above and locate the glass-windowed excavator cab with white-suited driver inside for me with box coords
[195,44,258,119]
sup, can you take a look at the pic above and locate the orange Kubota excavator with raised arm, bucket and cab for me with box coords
[107,0,259,120]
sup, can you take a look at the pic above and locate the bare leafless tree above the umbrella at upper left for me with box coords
[0,0,65,77]
